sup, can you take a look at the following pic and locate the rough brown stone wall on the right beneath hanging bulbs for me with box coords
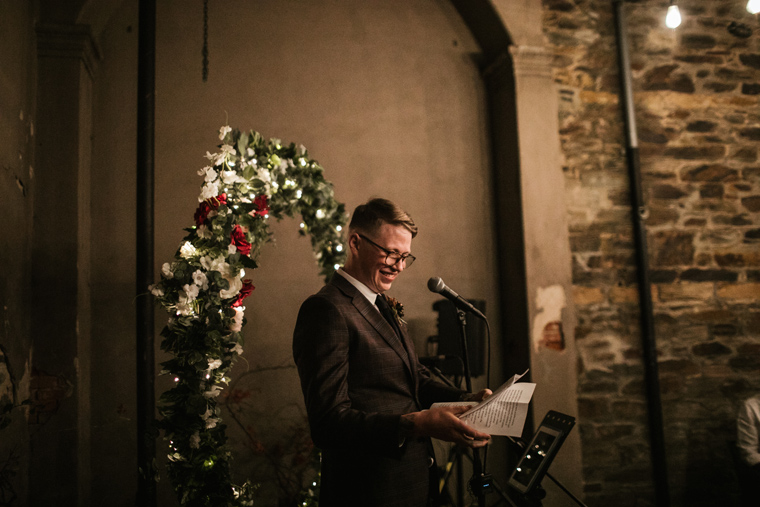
[543,0,760,507]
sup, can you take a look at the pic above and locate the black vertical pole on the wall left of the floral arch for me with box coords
[135,0,156,507]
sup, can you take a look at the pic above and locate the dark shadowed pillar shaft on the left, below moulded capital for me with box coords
[29,21,97,506]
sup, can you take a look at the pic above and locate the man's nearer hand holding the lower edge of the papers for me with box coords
[401,407,491,448]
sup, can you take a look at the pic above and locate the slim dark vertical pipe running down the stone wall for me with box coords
[614,0,670,507]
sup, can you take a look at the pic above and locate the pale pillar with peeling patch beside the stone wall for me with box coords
[510,45,583,506]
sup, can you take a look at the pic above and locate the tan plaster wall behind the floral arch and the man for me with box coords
[92,0,505,505]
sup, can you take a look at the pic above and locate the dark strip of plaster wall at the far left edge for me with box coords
[0,2,35,501]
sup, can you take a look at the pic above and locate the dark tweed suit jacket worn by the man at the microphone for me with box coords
[293,275,463,507]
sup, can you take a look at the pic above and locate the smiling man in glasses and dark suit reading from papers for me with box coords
[293,199,491,507]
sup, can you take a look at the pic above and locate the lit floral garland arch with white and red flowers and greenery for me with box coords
[150,126,346,507]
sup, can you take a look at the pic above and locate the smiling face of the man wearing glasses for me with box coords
[347,224,412,293]
